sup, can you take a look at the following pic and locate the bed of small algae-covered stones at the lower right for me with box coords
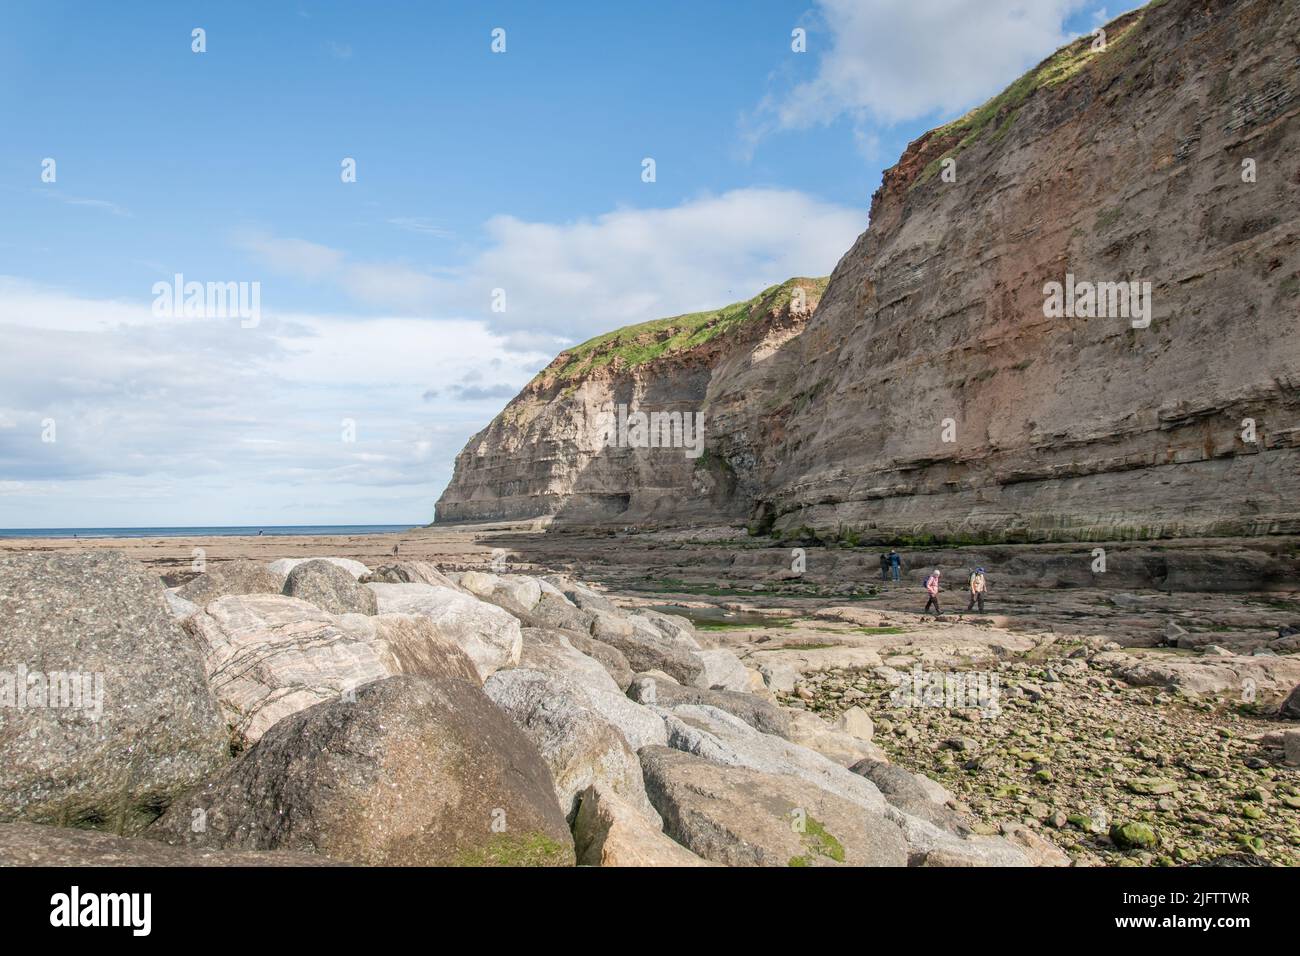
[785,648,1300,866]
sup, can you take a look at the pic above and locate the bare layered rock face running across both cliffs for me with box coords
[438,0,1300,541]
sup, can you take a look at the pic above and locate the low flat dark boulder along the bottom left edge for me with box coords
[0,823,339,866]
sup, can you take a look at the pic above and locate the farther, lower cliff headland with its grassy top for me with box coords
[437,278,826,524]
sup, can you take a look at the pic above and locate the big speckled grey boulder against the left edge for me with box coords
[0,551,230,834]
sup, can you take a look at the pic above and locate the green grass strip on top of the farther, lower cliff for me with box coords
[543,278,829,382]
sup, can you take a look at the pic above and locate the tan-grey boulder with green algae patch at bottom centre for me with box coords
[640,747,907,866]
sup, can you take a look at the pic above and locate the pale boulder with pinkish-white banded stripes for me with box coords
[185,594,477,743]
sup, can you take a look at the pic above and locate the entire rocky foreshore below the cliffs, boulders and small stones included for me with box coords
[0,532,1300,866]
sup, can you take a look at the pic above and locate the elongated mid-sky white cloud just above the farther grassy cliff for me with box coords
[243,189,867,351]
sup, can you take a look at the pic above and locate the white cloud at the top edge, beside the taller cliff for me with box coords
[744,0,1107,140]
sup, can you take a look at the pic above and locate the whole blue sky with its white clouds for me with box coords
[0,0,1132,527]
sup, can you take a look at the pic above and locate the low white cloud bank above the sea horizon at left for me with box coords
[0,277,550,527]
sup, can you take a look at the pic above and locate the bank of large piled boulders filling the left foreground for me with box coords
[0,550,1097,866]
